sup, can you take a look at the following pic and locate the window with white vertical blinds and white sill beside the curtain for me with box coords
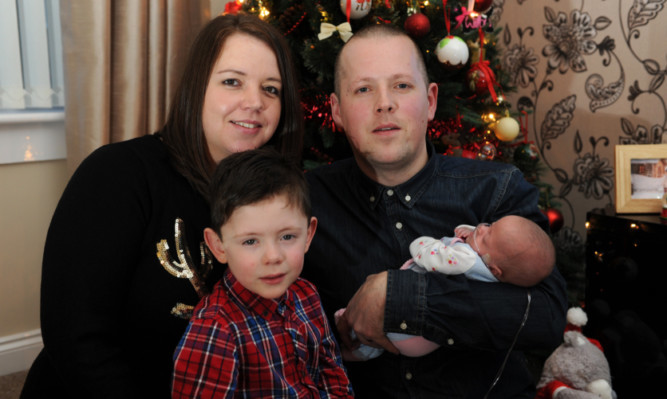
[0,0,65,163]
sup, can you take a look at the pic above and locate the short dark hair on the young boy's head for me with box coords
[208,148,312,234]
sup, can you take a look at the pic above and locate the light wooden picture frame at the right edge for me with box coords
[615,144,667,213]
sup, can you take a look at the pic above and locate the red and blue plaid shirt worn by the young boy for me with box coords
[172,270,353,398]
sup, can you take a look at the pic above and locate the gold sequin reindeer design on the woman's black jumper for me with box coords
[157,218,213,319]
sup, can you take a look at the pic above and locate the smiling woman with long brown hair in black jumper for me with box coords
[21,15,303,398]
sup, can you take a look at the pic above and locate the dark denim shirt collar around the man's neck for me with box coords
[353,140,437,209]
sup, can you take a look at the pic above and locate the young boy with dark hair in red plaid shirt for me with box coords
[172,150,353,398]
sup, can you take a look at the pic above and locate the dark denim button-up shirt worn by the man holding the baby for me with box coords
[303,145,567,397]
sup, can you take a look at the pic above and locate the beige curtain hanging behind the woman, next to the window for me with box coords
[60,0,210,173]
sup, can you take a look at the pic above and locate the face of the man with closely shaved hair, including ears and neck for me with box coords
[331,36,438,185]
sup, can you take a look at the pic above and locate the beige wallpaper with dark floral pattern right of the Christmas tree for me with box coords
[491,0,667,242]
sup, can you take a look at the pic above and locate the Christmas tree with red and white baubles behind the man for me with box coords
[235,0,538,173]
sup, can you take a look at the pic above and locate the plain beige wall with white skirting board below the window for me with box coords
[0,160,68,375]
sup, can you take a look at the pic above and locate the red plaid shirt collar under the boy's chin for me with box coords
[223,268,294,320]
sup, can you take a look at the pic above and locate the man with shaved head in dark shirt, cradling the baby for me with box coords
[304,25,567,399]
